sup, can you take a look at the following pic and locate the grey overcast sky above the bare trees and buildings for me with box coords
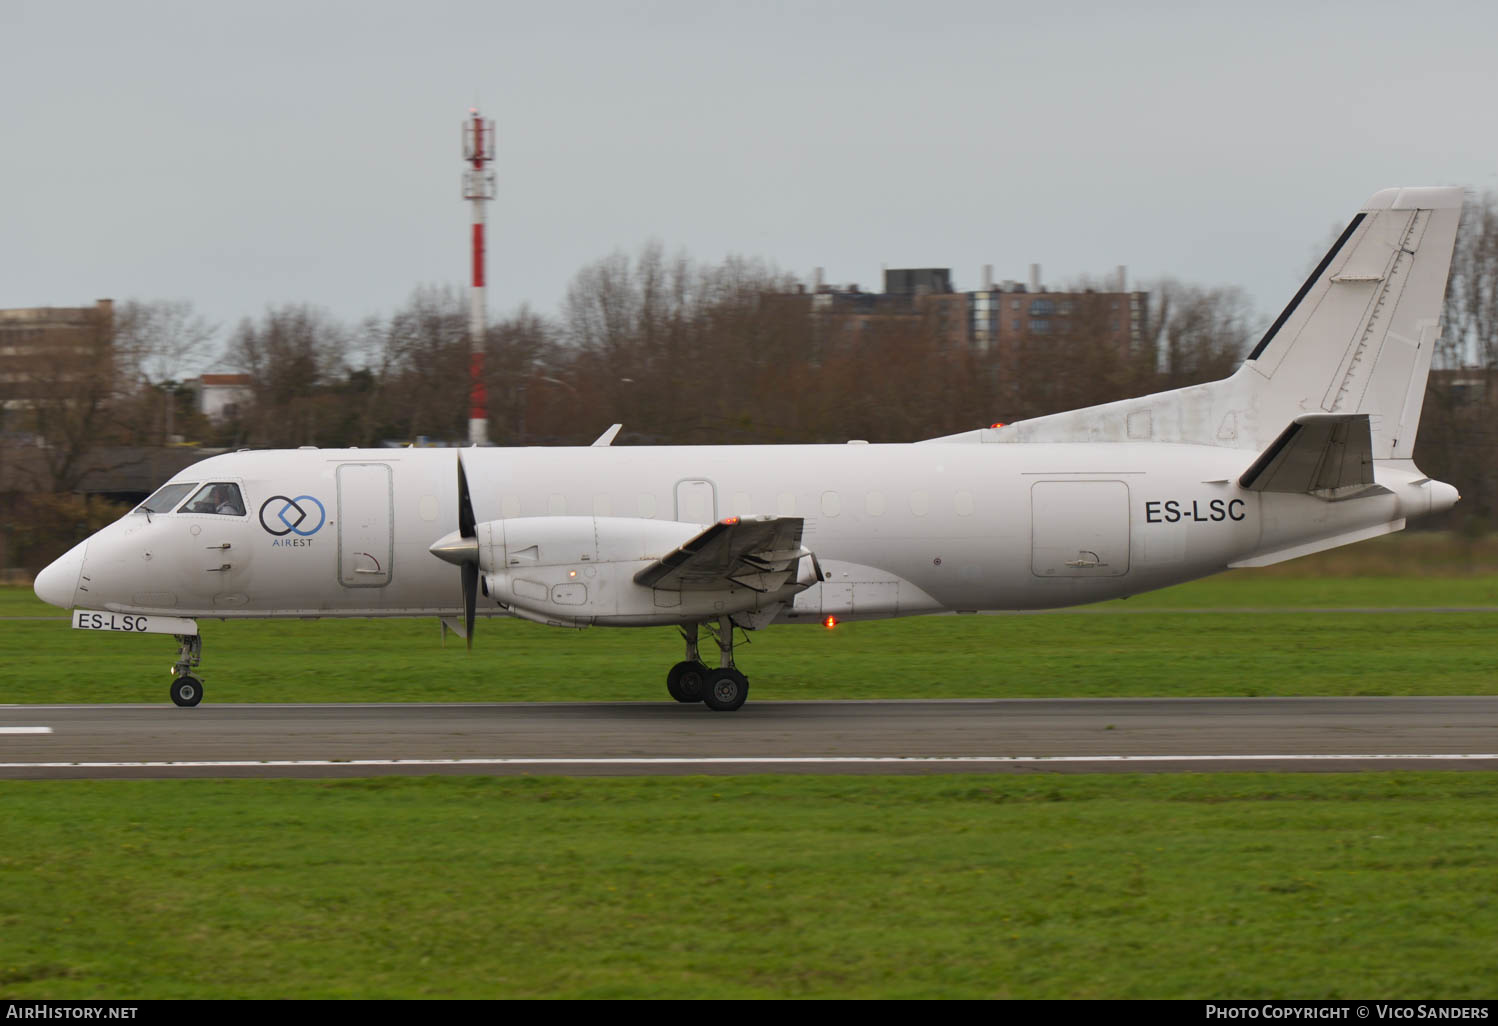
[0,0,1498,365]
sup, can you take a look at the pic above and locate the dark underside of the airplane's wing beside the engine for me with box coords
[635,515,809,592]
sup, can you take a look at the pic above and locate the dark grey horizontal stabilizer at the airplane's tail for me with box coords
[1237,413,1386,502]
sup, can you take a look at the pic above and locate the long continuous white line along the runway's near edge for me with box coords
[0,752,1498,770]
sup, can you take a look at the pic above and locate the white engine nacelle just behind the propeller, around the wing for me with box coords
[475,517,816,628]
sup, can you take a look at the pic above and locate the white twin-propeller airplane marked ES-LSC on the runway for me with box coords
[36,189,1462,711]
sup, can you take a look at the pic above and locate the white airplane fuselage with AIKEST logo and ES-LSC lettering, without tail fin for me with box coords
[54,443,1455,626]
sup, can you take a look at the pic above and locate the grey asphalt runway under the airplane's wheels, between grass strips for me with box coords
[0,696,1498,779]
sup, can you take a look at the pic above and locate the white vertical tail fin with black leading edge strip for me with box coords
[932,187,1462,460]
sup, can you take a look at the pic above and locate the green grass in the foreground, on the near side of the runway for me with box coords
[0,773,1498,999]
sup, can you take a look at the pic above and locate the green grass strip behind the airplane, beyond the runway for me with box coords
[0,574,1498,702]
